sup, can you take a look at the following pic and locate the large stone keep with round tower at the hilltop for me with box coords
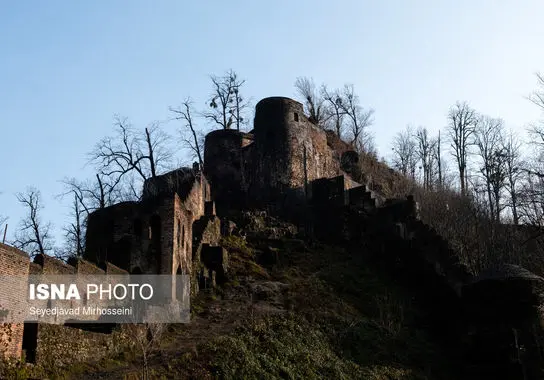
[204,97,364,215]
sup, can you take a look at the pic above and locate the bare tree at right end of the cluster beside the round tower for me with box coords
[341,85,374,150]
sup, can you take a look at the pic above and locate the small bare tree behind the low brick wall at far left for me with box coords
[13,187,53,256]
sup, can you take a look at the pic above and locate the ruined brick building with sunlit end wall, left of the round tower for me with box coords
[85,169,210,274]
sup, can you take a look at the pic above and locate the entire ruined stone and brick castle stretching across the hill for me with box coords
[0,97,544,378]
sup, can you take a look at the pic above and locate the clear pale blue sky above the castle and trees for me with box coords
[0,0,544,246]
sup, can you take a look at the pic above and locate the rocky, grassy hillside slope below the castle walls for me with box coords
[26,213,464,379]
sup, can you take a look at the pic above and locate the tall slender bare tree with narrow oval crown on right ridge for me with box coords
[448,102,477,195]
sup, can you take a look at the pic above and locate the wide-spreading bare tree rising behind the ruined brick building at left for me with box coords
[90,117,172,197]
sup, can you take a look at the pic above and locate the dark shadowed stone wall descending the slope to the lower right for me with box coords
[349,194,544,380]
